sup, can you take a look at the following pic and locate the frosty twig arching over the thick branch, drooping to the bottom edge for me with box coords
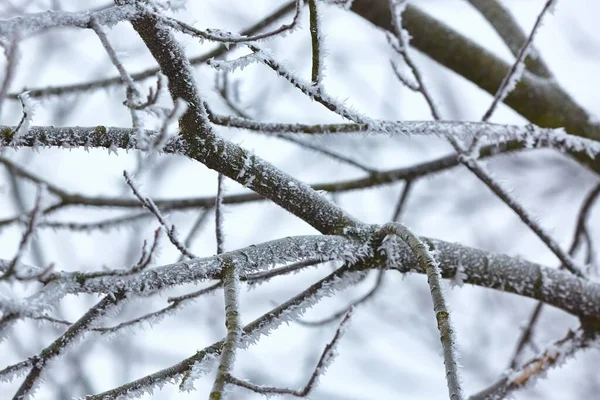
[380,222,463,400]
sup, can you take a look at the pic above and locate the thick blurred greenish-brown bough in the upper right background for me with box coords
[352,0,600,173]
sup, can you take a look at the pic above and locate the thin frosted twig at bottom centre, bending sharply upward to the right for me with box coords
[228,306,354,397]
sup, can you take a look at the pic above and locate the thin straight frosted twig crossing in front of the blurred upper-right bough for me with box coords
[481,0,556,122]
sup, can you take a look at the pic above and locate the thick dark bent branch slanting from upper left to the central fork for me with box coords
[126,10,360,234]
